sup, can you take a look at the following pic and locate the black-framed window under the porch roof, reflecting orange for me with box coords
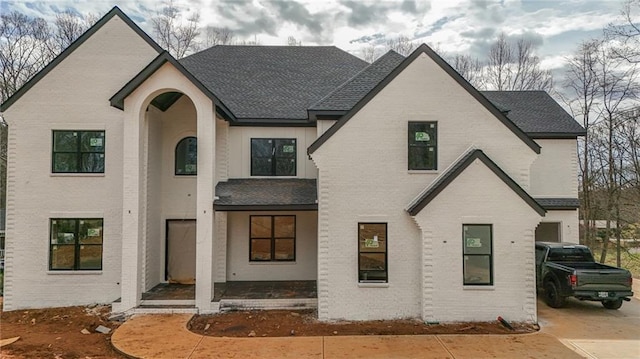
[249,216,296,262]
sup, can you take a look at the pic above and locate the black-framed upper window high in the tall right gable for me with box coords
[408,122,438,170]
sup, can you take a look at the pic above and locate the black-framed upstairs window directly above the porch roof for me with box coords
[251,138,297,176]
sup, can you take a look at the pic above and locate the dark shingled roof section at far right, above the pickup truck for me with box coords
[481,91,585,138]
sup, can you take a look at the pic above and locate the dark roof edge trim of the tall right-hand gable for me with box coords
[307,44,540,154]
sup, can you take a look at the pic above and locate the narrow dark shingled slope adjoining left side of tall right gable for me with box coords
[309,50,404,111]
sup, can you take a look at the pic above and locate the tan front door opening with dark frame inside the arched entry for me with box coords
[165,219,196,284]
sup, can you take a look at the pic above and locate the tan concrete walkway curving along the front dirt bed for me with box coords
[111,314,582,359]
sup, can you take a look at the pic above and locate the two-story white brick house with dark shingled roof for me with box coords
[0,8,584,322]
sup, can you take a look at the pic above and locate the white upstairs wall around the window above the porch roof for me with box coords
[228,126,317,178]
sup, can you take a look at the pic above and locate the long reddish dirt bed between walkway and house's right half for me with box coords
[189,310,538,337]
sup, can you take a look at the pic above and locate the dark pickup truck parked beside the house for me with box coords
[536,242,633,309]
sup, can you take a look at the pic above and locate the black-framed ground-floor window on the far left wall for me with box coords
[49,218,103,270]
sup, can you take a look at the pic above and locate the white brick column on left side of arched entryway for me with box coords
[114,102,145,311]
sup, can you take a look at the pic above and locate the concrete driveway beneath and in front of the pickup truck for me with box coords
[538,286,640,359]
